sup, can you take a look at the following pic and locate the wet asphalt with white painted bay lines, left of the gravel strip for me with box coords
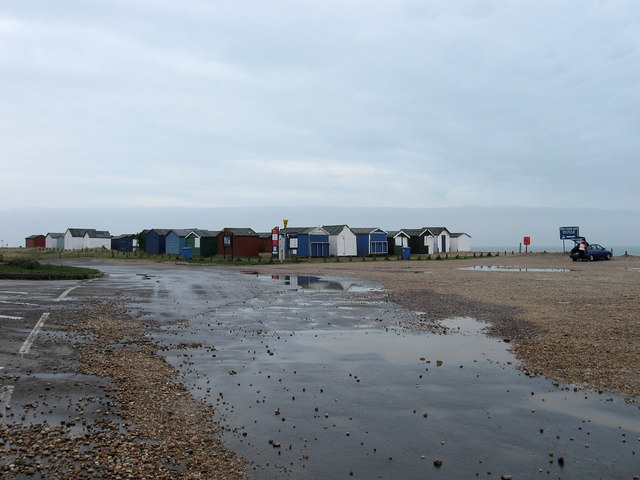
[0,281,110,425]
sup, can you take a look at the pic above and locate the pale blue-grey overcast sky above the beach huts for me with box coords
[0,0,640,246]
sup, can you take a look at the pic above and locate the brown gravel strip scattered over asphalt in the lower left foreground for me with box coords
[0,301,245,479]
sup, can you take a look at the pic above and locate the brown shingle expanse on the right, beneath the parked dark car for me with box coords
[245,253,640,396]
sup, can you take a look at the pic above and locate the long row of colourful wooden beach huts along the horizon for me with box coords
[26,224,471,257]
